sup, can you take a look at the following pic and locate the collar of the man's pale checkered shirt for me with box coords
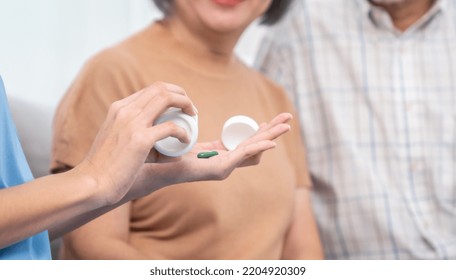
[357,0,448,34]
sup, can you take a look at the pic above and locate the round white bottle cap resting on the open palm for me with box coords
[222,115,259,151]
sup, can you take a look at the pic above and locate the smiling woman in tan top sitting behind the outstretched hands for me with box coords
[51,0,322,259]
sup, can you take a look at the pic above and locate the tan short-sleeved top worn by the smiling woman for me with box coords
[51,20,310,259]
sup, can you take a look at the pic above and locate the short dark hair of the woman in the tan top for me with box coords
[153,0,293,25]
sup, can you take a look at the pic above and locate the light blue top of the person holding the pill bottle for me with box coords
[0,77,51,260]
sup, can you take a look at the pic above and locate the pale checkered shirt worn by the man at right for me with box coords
[256,0,456,259]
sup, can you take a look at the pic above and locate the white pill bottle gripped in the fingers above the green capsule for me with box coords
[154,108,198,157]
